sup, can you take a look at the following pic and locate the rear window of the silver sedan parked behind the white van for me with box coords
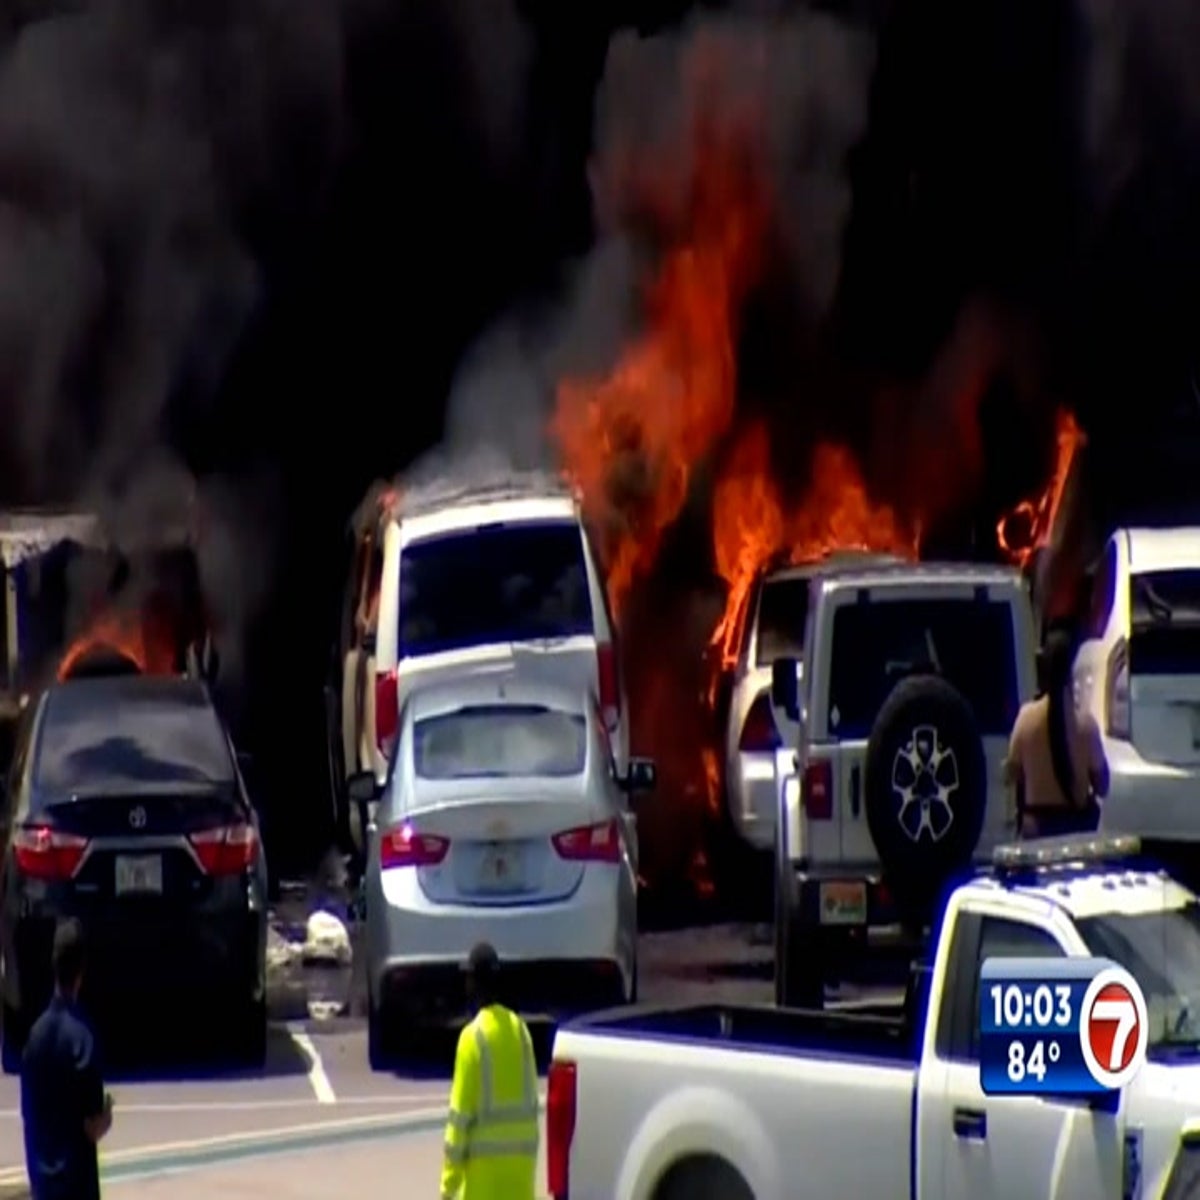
[413,704,588,779]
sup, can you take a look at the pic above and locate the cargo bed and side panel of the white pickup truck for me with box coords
[554,1004,920,1200]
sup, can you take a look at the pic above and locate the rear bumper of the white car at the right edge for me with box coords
[1100,740,1200,842]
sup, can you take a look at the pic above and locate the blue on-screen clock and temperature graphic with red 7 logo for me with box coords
[979,959,1150,1096]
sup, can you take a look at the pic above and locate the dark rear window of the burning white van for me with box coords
[400,521,594,659]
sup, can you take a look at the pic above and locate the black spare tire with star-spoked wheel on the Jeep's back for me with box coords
[863,674,988,908]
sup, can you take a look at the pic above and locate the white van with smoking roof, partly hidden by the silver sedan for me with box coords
[332,474,629,840]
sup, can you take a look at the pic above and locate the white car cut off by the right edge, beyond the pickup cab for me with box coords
[1072,527,1200,887]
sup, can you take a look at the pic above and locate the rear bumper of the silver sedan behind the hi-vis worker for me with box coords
[366,865,637,1013]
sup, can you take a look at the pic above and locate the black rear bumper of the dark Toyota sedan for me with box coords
[5,881,266,1014]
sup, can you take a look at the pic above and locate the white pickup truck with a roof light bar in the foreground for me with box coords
[547,839,1200,1200]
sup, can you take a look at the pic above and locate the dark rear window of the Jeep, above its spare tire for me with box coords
[829,600,1019,738]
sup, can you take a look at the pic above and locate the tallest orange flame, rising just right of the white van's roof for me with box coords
[551,38,768,616]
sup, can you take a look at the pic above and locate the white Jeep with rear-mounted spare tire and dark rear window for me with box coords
[772,564,1037,1006]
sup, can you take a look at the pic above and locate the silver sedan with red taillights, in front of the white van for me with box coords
[352,676,654,1067]
